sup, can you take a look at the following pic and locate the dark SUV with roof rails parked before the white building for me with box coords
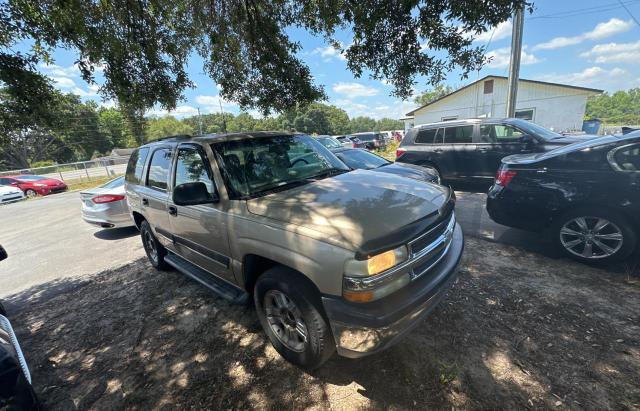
[396,118,596,180]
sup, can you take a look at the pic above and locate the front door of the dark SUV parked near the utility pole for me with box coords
[476,123,535,178]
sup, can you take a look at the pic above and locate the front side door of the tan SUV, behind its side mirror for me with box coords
[168,143,234,281]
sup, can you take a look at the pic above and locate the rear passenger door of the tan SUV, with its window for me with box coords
[139,146,174,251]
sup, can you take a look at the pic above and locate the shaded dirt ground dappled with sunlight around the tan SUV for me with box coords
[6,238,640,410]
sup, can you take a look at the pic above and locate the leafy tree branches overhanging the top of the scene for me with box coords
[0,0,531,117]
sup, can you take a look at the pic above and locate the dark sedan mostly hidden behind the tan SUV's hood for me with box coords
[331,148,440,184]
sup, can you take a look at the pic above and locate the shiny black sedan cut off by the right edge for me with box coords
[487,132,640,263]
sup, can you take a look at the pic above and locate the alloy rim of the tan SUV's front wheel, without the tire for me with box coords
[264,290,308,352]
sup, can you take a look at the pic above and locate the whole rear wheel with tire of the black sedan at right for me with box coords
[551,208,638,264]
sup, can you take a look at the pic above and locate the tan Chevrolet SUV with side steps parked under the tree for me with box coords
[126,132,463,369]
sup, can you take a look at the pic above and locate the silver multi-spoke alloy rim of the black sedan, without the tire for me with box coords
[560,216,624,260]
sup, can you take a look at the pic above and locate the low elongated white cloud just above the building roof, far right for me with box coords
[537,66,640,91]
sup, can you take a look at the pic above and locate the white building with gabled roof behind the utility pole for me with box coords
[401,76,602,131]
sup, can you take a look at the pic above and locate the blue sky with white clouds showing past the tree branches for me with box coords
[27,0,640,118]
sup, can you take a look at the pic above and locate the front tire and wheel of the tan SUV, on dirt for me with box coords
[253,266,336,371]
